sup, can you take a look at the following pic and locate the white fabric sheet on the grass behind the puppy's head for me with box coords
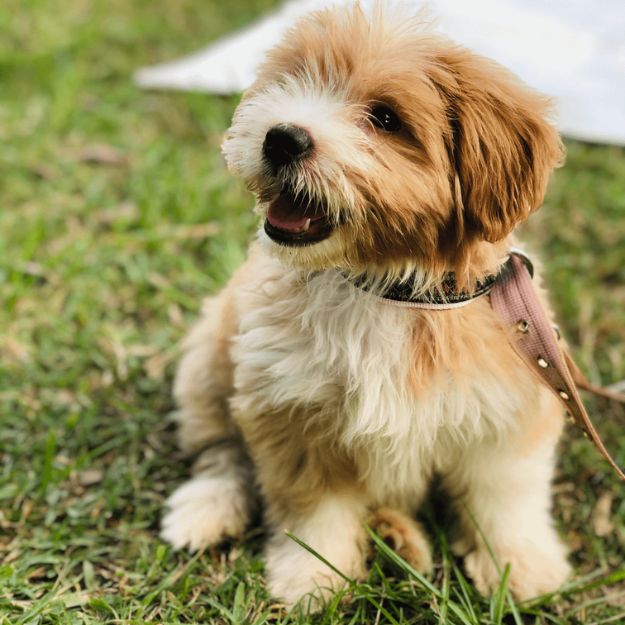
[135,0,625,145]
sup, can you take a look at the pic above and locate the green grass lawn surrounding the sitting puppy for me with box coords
[0,0,625,625]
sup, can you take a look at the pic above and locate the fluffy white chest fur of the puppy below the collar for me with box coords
[233,262,527,504]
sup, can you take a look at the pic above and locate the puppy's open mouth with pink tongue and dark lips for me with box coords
[265,189,333,246]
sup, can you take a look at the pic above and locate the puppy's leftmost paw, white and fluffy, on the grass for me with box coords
[161,476,249,551]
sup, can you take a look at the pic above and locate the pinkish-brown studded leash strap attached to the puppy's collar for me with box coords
[490,251,625,480]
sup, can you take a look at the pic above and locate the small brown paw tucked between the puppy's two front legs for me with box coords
[369,508,432,574]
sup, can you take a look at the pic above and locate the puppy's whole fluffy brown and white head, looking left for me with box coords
[223,6,562,273]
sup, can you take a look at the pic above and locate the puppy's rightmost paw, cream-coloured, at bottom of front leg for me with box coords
[464,543,571,601]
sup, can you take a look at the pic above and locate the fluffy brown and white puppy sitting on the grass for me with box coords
[163,6,569,604]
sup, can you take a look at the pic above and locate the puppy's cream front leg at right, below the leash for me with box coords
[446,402,570,600]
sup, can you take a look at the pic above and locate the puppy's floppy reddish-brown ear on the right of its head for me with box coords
[434,47,564,242]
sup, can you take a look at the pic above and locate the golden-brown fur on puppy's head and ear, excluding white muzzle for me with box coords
[250,2,563,284]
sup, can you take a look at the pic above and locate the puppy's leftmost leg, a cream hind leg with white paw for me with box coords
[161,291,255,550]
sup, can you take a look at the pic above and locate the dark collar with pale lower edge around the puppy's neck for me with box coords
[350,249,533,310]
